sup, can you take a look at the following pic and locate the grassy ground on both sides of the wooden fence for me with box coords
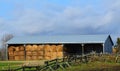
[0,61,120,71]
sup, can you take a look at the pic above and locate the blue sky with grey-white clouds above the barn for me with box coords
[0,0,120,46]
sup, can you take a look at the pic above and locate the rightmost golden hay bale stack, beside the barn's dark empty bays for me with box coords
[44,45,63,60]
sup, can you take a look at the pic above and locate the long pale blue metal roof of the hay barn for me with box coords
[7,35,109,44]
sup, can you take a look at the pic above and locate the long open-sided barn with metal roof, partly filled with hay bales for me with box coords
[6,35,114,60]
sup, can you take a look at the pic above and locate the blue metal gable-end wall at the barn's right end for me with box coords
[104,37,113,53]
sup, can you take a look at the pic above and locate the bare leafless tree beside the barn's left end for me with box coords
[0,34,13,60]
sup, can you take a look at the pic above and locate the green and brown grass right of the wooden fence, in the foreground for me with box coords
[58,61,120,71]
